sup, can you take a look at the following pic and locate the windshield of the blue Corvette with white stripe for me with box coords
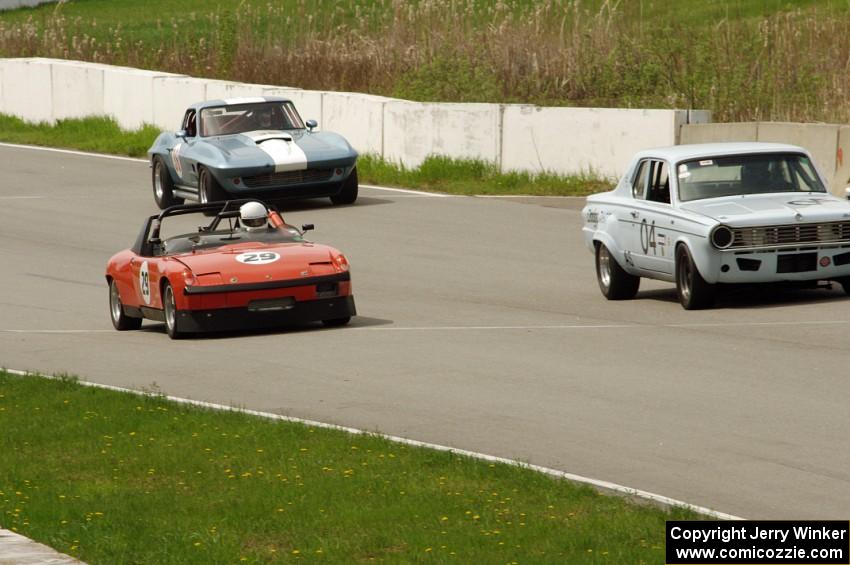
[201,102,304,137]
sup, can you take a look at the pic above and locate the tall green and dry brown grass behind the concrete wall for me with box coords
[0,0,850,122]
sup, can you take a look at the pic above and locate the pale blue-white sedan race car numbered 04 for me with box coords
[582,143,850,310]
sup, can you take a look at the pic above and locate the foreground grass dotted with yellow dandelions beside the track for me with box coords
[0,370,696,565]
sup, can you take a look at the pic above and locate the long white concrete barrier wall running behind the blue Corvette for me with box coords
[0,59,724,178]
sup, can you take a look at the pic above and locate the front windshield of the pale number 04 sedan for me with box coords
[676,153,826,202]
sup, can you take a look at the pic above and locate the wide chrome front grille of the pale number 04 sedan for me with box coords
[729,222,850,249]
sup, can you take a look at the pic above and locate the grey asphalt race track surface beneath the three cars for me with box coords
[0,146,850,519]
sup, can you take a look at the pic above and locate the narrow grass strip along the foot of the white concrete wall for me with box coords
[0,114,611,196]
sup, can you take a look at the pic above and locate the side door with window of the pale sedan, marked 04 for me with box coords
[632,159,675,275]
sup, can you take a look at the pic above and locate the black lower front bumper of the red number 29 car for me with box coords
[177,295,357,333]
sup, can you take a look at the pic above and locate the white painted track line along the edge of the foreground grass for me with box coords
[5,369,744,520]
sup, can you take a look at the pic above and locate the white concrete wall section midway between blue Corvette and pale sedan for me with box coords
[383,100,501,167]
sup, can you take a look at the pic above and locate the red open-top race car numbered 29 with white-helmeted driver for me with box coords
[106,200,356,339]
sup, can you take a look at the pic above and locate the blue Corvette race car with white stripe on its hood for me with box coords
[148,97,358,210]
